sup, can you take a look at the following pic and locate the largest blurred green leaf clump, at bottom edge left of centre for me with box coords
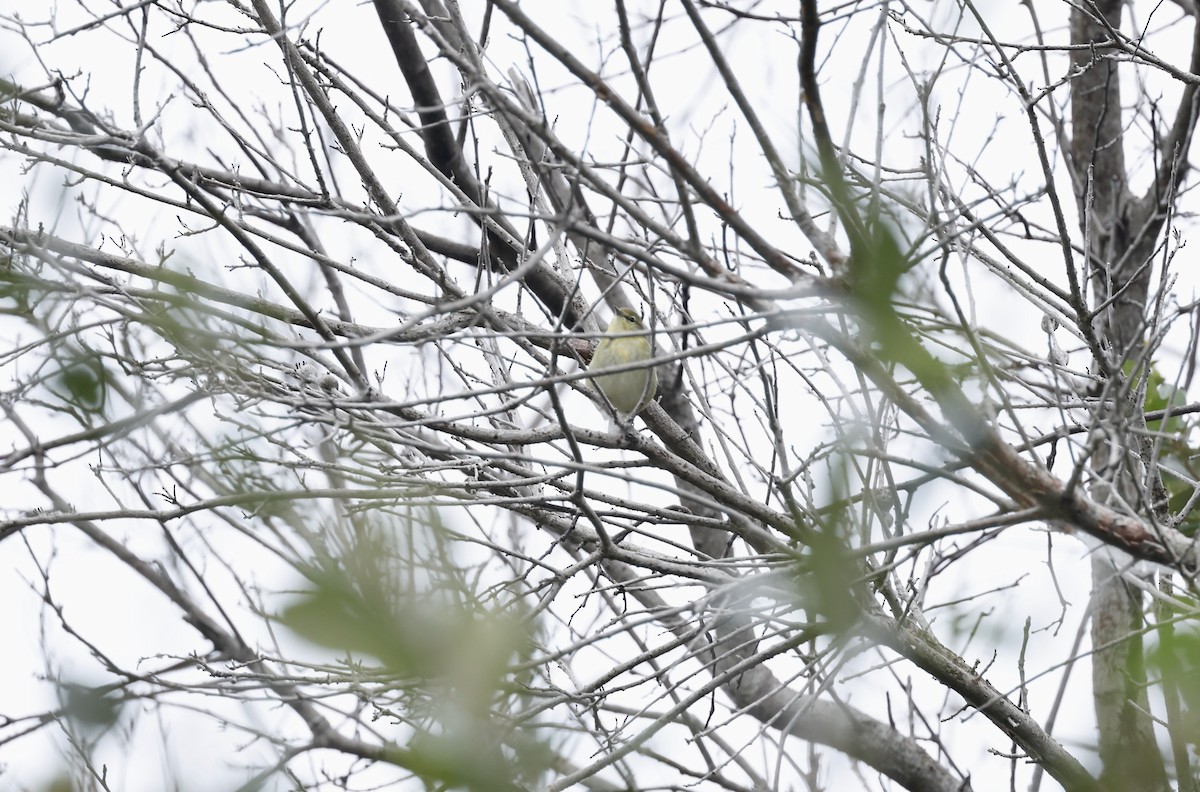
[281,518,556,792]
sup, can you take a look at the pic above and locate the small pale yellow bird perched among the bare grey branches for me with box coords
[588,308,659,421]
